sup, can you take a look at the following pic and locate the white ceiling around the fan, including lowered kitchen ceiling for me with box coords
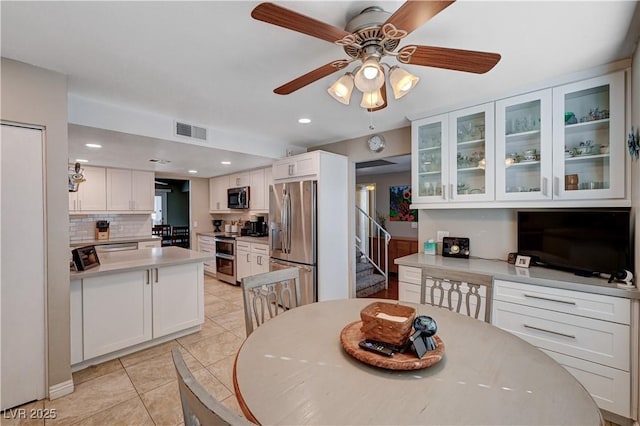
[0,0,640,177]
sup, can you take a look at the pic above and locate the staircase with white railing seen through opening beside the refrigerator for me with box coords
[356,205,391,297]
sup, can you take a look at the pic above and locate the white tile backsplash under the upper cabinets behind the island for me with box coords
[69,214,153,243]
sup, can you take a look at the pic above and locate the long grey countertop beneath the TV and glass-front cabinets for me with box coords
[395,253,640,299]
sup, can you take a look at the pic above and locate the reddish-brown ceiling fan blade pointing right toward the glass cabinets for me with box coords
[396,45,501,74]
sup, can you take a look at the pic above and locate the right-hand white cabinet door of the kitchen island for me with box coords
[153,263,204,338]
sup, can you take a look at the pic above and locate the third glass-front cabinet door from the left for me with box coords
[496,89,553,201]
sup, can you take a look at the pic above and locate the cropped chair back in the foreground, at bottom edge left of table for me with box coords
[171,348,253,426]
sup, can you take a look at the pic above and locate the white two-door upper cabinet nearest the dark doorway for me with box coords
[107,169,155,213]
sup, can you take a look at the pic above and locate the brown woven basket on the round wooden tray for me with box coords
[360,302,416,346]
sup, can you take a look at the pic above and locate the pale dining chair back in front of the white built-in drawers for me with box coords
[420,267,493,322]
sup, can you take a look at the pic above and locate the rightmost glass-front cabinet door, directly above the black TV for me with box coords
[553,71,625,199]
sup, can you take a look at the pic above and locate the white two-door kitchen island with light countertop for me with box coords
[70,247,212,371]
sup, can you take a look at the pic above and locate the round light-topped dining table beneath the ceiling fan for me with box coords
[234,299,603,425]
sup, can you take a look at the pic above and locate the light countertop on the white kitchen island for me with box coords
[70,246,214,281]
